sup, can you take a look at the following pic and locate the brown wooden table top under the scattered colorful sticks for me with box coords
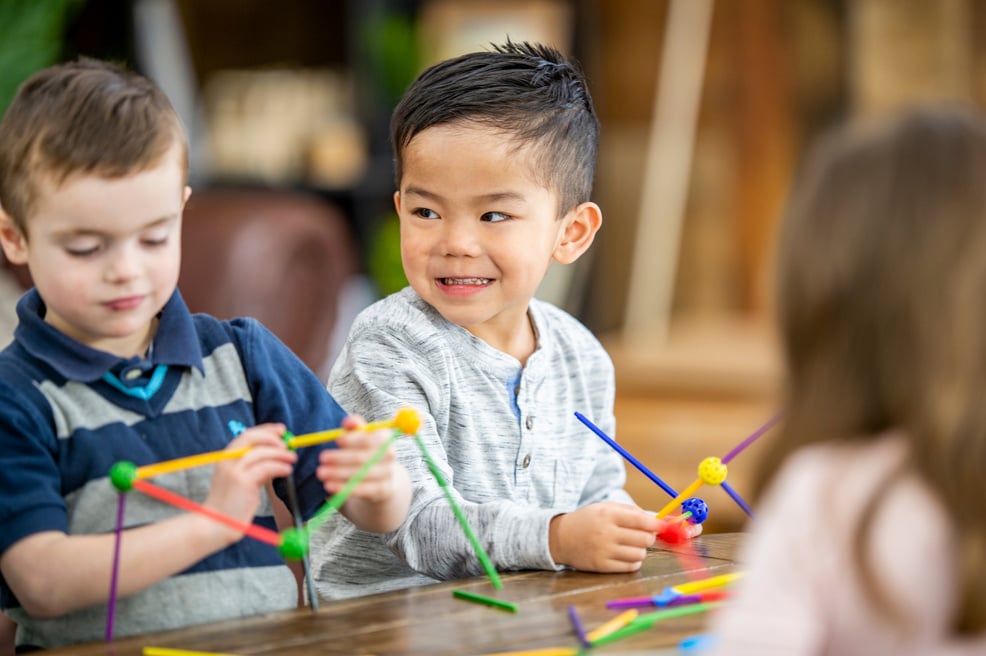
[45,533,742,656]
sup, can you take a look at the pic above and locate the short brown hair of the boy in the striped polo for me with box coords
[0,58,188,234]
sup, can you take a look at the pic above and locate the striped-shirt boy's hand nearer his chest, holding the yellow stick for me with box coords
[203,424,297,543]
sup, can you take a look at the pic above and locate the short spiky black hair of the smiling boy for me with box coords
[390,40,599,215]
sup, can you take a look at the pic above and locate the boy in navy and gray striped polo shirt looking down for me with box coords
[0,60,409,648]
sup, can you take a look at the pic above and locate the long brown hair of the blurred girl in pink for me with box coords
[758,106,986,634]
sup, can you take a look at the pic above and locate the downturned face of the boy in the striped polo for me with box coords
[0,147,191,357]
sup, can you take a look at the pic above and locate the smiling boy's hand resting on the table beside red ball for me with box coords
[548,501,661,572]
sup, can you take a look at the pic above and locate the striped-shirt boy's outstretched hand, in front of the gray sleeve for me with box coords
[315,416,411,533]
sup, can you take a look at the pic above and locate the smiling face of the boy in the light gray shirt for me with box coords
[394,124,601,352]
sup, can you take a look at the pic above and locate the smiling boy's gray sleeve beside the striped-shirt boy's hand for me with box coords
[329,326,560,579]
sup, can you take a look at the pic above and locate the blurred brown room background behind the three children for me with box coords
[0,0,986,530]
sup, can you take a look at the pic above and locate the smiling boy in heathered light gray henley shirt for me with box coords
[313,42,688,597]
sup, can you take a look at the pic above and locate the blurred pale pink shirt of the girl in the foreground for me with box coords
[711,436,986,656]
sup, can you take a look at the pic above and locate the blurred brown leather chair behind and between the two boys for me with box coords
[0,189,357,380]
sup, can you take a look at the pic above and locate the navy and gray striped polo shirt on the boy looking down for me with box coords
[0,290,344,647]
